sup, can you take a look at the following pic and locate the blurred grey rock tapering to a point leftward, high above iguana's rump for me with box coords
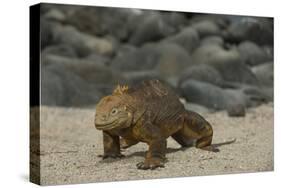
[162,27,200,52]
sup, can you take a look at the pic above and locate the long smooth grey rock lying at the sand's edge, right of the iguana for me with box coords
[180,79,267,111]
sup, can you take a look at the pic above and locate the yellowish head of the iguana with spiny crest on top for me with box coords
[95,87,133,130]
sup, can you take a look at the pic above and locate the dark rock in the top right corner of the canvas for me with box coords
[223,17,273,45]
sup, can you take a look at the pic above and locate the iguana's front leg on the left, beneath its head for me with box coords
[100,131,124,159]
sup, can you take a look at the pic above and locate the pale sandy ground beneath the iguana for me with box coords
[31,104,273,185]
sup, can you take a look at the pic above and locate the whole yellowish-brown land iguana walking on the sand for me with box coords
[95,80,235,169]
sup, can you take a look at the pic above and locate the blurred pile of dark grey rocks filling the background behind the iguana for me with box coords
[40,4,273,116]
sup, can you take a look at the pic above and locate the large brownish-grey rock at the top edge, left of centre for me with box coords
[66,6,134,40]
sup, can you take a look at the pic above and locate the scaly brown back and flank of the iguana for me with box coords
[124,80,185,124]
